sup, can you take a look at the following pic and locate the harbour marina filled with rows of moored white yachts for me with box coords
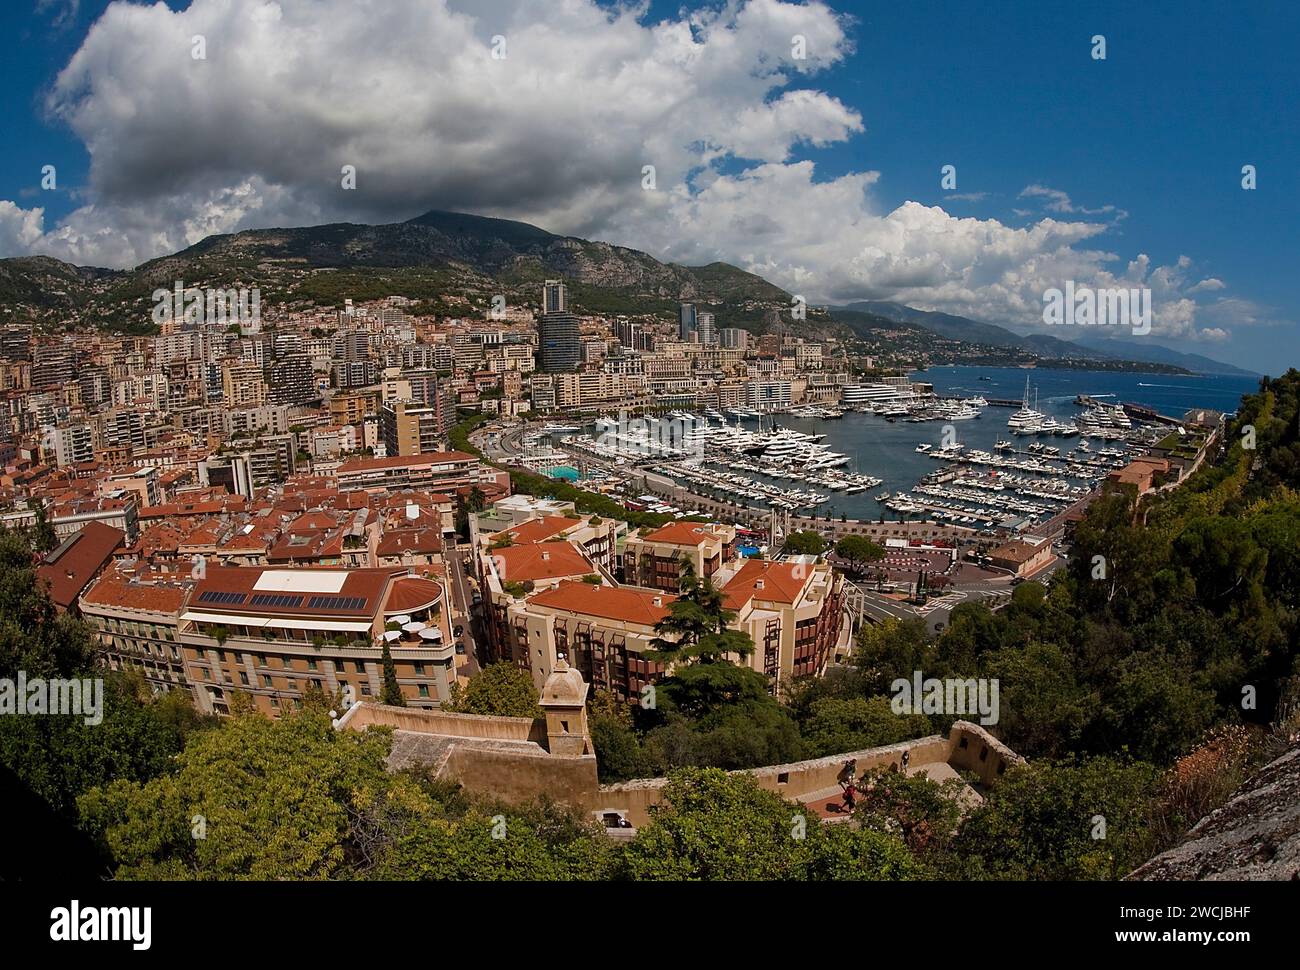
[514,368,1248,531]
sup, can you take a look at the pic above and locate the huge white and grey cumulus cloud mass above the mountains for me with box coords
[0,0,1249,335]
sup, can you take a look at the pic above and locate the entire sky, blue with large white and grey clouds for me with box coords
[0,0,1300,373]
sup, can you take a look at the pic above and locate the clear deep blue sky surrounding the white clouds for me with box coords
[0,0,1300,373]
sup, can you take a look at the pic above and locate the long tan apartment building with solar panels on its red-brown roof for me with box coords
[178,566,456,716]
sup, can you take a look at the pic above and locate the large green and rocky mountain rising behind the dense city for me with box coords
[0,211,790,330]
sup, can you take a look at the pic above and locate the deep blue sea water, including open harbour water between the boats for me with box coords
[733,365,1258,519]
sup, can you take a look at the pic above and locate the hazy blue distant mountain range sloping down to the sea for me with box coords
[831,300,1257,377]
